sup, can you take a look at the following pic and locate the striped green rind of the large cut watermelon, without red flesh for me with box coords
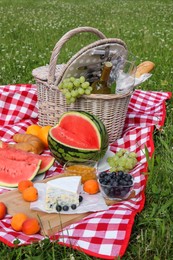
[48,111,109,164]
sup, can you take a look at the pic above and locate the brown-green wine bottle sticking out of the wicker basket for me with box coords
[91,61,112,94]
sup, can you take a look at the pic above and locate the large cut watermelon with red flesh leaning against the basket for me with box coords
[48,111,109,164]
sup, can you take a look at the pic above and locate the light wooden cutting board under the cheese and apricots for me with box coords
[0,174,135,236]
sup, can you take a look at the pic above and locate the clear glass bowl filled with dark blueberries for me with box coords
[98,171,133,200]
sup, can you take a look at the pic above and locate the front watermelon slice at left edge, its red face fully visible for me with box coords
[0,156,41,188]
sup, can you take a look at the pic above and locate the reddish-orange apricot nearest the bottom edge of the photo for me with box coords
[22,218,40,235]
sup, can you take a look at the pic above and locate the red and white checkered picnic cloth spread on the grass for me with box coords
[0,84,171,259]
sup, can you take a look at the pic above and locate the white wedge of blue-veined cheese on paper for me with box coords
[45,176,81,212]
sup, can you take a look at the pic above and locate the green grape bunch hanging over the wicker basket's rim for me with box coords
[58,76,92,105]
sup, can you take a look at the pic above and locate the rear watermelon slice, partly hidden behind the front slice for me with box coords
[0,142,55,174]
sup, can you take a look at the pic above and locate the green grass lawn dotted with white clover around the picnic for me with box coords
[0,0,173,260]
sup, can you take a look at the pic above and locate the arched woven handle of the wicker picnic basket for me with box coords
[48,27,106,85]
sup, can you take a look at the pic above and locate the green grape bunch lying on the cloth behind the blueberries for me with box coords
[107,149,138,172]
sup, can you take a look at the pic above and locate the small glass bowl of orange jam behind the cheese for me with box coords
[63,160,97,184]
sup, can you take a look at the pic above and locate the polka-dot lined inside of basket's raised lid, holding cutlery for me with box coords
[61,42,128,83]
